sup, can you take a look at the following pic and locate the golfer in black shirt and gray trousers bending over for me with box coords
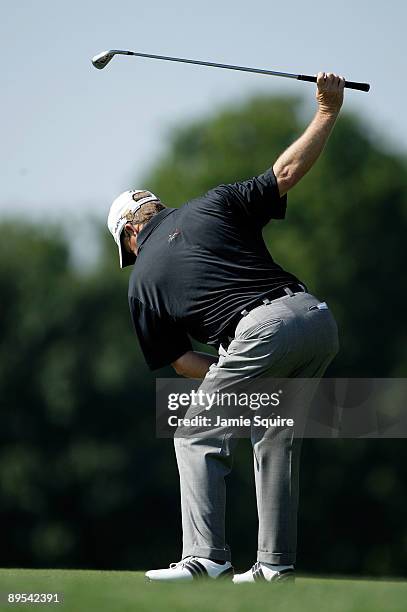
[108,72,344,583]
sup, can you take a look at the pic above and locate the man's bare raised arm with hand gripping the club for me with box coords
[273,72,345,196]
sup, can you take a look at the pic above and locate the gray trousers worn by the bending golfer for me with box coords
[174,293,338,564]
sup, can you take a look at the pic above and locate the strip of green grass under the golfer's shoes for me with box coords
[0,569,407,612]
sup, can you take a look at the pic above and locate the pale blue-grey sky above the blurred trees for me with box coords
[0,0,407,217]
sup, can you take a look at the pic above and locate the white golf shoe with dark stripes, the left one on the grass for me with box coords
[145,557,233,582]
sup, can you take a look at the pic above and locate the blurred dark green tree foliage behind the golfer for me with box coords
[0,97,407,575]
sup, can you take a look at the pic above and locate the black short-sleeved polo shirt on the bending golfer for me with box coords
[129,169,299,370]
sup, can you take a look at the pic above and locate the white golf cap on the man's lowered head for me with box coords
[107,189,160,268]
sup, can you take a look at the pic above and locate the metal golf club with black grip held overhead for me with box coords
[92,49,370,91]
